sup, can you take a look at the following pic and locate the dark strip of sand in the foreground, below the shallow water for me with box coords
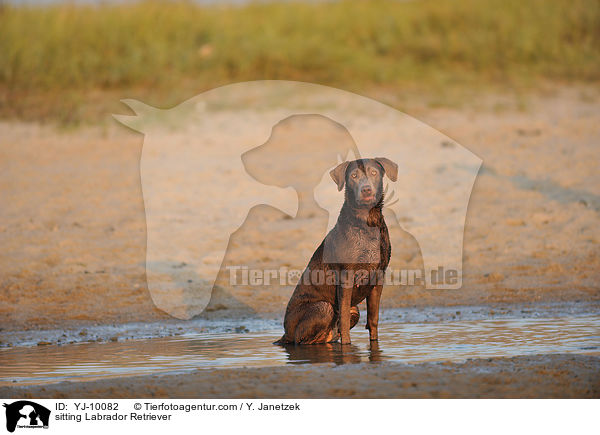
[0,355,600,398]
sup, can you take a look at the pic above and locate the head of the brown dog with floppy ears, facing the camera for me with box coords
[329,157,398,208]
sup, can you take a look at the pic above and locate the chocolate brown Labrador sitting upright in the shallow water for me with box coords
[275,157,398,344]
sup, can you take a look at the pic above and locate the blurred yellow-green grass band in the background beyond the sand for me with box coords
[0,0,600,120]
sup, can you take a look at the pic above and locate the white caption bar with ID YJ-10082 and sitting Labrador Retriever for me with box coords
[2,399,598,435]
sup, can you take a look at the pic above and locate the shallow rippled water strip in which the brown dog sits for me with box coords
[0,315,600,386]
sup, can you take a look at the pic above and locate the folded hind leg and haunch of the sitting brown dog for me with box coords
[294,301,335,344]
